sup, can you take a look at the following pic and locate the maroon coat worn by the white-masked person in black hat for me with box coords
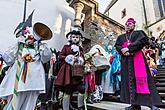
[55,45,84,88]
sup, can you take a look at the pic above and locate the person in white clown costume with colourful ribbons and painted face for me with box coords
[0,27,51,110]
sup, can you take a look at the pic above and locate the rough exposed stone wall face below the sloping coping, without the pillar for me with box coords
[83,9,124,45]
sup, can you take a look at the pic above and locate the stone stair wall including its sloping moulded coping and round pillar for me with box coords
[67,0,124,49]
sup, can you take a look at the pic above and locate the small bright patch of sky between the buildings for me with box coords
[97,0,111,13]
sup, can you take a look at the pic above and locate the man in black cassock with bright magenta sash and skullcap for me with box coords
[115,18,162,110]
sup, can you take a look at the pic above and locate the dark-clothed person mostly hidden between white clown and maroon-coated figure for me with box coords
[38,48,57,110]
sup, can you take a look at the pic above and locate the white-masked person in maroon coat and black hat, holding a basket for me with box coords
[55,30,85,110]
